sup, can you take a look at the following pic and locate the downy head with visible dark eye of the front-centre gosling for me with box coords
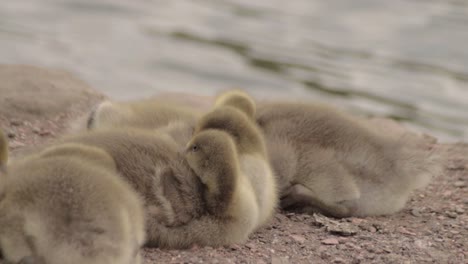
[186,129,236,175]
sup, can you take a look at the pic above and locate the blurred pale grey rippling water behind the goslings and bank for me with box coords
[0,0,468,141]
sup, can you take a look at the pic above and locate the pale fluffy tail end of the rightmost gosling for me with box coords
[356,133,445,216]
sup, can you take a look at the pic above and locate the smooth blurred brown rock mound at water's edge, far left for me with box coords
[0,65,104,120]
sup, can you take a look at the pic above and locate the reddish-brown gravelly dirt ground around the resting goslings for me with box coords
[0,64,468,264]
